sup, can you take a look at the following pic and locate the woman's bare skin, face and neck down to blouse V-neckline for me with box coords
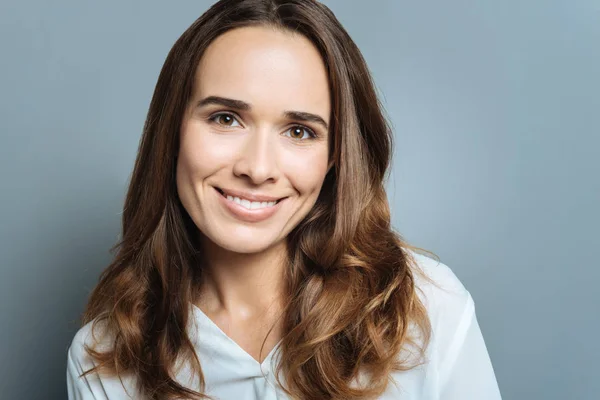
[177,27,331,362]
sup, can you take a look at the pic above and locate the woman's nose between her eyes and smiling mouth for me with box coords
[233,129,279,185]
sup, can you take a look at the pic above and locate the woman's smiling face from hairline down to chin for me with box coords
[177,27,330,253]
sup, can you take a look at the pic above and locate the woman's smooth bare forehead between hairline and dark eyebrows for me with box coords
[194,26,330,121]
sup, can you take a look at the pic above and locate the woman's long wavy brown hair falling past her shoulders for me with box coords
[83,0,440,400]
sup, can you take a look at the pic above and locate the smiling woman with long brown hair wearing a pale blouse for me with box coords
[67,0,500,400]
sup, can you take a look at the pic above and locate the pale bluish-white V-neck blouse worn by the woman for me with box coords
[66,250,501,400]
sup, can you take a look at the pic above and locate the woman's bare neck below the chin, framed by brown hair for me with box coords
[197,239,287,320]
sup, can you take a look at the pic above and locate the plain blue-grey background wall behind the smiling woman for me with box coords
[0,0,600,400]
